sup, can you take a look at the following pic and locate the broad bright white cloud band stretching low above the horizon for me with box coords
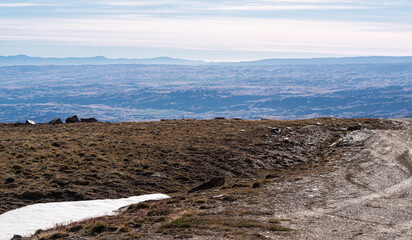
[0,15,412,55]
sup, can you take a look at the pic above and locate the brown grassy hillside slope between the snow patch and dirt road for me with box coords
[0,118,410,239]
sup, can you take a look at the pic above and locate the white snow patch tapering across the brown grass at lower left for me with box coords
[0,193,169,240]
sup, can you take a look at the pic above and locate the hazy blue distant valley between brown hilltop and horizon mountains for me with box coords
[0,63,412,122]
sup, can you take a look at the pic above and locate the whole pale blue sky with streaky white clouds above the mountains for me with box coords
[0,0,412,61]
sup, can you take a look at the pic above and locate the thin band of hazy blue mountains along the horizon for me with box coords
[0,55,412,66]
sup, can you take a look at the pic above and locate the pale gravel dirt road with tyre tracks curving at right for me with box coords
[265,119,412,239]
